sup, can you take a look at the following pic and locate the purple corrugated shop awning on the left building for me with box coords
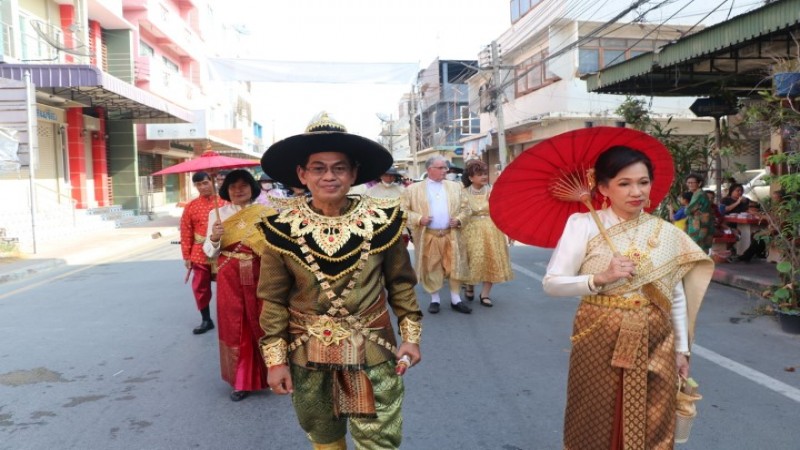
[0,64,193,122]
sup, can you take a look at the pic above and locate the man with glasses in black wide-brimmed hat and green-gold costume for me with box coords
[258,114,422,449]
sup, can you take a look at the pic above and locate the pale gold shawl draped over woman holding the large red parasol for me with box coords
[580,213,714,345]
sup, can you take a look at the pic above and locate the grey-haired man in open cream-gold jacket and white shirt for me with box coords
[400,156,472,314]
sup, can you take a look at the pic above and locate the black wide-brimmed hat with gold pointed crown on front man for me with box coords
[261,112,393,187]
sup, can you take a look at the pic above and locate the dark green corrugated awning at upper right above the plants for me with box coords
[583,0,800,96]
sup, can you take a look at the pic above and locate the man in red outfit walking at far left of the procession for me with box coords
[180,172,222,334]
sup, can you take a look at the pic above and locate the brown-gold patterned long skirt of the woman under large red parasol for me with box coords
[564,301,677,450]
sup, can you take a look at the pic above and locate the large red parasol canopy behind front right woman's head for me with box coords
[489,127,674,248]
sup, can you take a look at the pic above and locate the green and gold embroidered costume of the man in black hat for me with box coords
[258,196,422,449]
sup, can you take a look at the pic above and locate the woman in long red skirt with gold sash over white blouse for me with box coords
[203,169,275,402]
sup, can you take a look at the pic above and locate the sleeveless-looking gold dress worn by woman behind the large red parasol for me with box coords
[462,185,514,284]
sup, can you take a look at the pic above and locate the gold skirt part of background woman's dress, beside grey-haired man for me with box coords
[462,216,514,284]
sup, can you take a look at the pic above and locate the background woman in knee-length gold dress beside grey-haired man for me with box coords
[461,160,514,307]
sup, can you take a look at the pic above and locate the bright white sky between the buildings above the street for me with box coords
[220,0,510,143]
